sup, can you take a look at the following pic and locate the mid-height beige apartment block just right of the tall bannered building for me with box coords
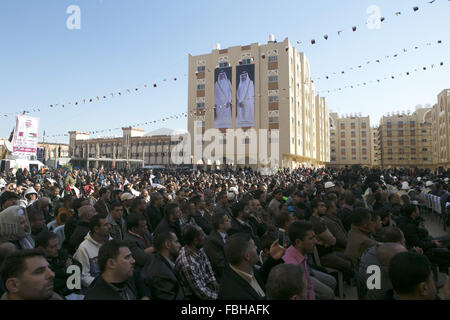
[329,113,374,168]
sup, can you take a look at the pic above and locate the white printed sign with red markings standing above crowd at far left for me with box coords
[12,115,39,156]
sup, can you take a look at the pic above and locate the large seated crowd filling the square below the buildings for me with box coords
[0,167,450,300]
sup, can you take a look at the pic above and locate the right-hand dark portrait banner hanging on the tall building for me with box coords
[236,64,255,128]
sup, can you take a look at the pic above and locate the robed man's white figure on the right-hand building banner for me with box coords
[236,71,255,127]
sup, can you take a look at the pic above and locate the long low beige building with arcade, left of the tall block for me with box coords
[69,127,186,168]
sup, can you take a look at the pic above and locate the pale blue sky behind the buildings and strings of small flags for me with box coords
[0,0,450,143]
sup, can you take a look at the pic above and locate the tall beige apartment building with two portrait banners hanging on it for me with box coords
[188,36,330,168]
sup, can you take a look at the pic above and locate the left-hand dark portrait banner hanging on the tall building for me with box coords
[214,67,233,129]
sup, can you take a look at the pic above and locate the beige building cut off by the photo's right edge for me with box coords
[432,89,450,168]
